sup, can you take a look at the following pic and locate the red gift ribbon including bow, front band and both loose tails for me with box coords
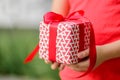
[24,10,96,77]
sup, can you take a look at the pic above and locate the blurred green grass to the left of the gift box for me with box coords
[0,29,59,80]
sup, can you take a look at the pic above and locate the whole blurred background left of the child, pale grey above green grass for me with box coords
[0,0,59,80]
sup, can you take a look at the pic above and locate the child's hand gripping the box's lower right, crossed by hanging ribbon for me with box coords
[68,46,105,72]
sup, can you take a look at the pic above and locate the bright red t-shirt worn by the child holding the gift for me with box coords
[60,0,120,80]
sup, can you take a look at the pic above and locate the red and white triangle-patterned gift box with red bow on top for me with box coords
[39,11,94,64]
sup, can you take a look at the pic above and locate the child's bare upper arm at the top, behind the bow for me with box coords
[51,0,70,17]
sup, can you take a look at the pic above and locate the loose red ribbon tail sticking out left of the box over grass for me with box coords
[24,44,39,64]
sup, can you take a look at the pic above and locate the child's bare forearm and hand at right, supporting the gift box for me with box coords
[68,40,120,71]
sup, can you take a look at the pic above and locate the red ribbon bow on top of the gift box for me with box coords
[44,10,84,24]
